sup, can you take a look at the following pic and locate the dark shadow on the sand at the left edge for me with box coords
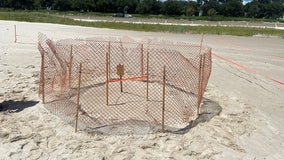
[0,100,39,113]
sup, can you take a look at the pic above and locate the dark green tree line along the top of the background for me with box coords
[0,0,284,19]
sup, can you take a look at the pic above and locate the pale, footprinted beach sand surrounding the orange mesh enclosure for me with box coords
[0,21,284,160]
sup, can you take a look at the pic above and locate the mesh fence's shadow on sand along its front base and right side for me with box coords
[82,98,222,135]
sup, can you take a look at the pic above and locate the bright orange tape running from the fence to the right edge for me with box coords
[212,52,284,86]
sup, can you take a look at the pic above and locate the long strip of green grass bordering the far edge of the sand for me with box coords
[0,11,284,38]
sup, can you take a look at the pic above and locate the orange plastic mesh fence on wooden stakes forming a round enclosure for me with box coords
[38,34,211,134]
